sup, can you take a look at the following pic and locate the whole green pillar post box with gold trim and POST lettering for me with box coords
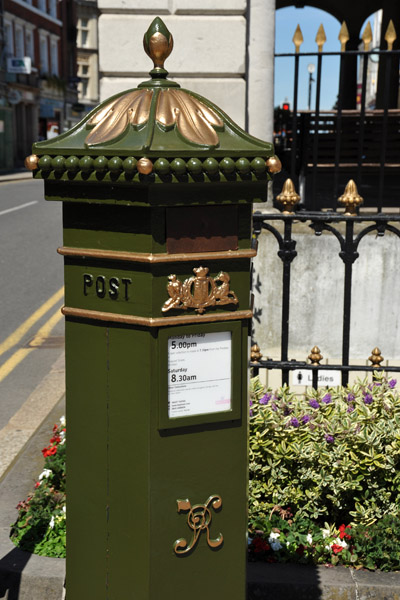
[27,18,278,600]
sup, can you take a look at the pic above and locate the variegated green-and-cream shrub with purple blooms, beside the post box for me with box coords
[250,372,400,525]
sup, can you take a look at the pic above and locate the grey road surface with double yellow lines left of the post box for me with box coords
[0,180,64,431]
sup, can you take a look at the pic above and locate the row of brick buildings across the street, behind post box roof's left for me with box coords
[0,0,77,169]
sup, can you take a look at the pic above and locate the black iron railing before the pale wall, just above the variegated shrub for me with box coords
[250,211,400,388]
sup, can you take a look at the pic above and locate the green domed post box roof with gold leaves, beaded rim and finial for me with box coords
[26,17,279,184]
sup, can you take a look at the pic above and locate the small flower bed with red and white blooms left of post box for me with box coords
[10,417,66,558]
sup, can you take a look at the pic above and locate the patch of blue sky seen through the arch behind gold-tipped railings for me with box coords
[274,6,372,110]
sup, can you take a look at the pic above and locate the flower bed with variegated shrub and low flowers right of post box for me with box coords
[249,372,400,570]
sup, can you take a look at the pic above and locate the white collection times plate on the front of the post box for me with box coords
[168,331,232,419]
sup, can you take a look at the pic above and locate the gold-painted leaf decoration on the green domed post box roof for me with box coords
[85,88,224,146]
